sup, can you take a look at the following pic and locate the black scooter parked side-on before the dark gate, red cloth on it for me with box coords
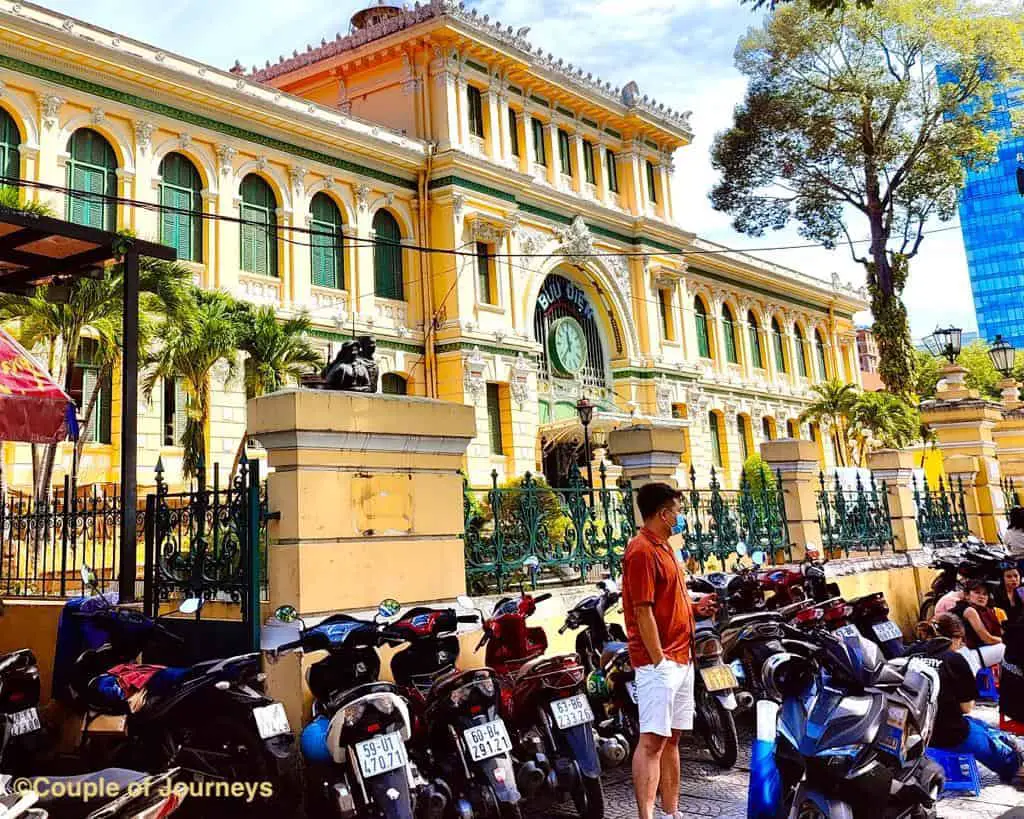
[55,567,302,815]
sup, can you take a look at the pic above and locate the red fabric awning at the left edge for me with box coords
[0,329,78,443]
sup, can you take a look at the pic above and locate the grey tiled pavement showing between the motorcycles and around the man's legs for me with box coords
[529,707,1024,819]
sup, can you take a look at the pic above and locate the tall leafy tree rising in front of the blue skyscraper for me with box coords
[711,0,1024,392]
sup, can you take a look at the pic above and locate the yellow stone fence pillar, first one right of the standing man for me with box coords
[761,438,822,561]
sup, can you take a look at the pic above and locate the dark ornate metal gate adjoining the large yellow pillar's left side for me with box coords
[144,458,266,661]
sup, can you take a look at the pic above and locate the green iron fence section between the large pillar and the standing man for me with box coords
[463,463,636,594]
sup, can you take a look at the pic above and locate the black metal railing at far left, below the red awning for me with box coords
[0,476,144,598]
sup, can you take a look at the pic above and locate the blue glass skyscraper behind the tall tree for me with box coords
[940,72,1024,347]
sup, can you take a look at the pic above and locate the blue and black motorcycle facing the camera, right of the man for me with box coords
[763,630,943,819]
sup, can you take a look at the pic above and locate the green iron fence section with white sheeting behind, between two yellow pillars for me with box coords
[818,472,893,557]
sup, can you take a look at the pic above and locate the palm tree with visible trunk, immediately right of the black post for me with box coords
[142,288,238,477]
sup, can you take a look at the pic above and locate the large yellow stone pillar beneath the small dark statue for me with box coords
[247,390,476,614]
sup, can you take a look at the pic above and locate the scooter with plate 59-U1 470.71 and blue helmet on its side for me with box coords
[272,600,447,819]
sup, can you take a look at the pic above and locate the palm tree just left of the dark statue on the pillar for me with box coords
[231,304,324,476]
